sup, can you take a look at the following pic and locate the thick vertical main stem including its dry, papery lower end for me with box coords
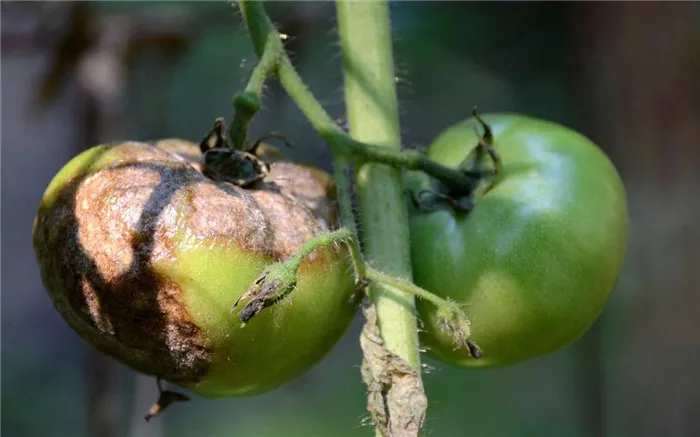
[336,0,427,437]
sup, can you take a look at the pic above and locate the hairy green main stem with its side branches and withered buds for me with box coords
[231,0,478,437]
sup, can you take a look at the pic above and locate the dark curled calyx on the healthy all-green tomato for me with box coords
[410,108,502,213]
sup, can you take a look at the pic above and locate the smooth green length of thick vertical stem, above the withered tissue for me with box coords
[337,0,420,378]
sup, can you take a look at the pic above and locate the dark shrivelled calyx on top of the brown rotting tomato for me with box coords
[199,118,292,188]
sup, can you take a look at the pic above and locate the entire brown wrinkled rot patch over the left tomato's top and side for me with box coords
[34,138,344,383]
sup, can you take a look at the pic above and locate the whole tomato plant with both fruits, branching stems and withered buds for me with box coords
[34,0,627,430]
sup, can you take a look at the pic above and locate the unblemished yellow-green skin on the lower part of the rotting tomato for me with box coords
[162,238,352,397]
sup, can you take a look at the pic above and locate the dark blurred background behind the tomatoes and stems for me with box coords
[0,0,700,437]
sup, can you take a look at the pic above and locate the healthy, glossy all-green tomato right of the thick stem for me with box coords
[410,114,628,368]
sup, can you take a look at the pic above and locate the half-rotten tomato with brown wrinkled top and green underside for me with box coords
[33,140,358,396]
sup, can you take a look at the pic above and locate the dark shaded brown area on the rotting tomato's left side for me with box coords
[35,151,252,382]
